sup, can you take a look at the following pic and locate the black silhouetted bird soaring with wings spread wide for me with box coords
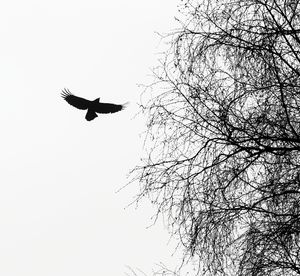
[61,88,128,121]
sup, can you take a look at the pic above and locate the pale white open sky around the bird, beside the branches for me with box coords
[0,0,183,276]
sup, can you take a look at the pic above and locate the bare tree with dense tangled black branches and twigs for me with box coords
[134,0,300,276]
